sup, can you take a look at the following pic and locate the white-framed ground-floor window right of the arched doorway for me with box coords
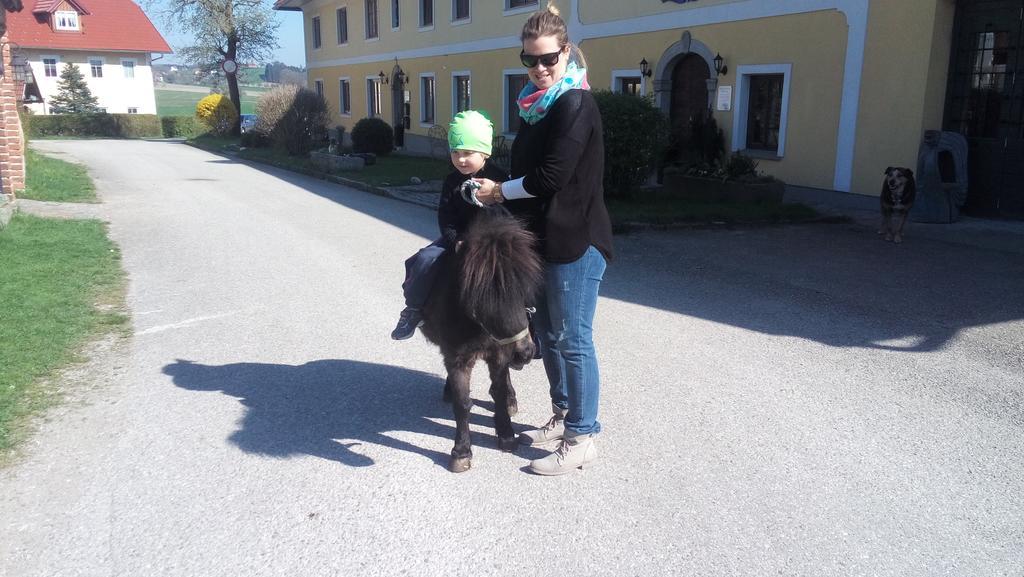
[731,64,793,158]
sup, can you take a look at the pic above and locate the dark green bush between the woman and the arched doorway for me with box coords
[594,90,668,197]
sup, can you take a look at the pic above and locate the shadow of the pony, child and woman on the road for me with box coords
[163,360,536,466]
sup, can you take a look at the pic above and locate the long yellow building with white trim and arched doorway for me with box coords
[275,0,1024,216]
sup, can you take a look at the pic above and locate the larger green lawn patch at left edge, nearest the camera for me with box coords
[0,214,127,461]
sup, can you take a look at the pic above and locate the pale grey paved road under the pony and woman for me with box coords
[0,140,1024,577]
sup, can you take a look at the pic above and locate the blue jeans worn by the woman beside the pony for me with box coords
[534,246,607,435]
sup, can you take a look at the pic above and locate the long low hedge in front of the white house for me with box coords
[29,113,164,138]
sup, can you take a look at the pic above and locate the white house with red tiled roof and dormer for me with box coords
[7,0,171,114]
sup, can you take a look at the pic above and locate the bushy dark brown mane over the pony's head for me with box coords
[459,211,544,312]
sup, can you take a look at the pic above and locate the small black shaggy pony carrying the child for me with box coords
[421,209,544,472]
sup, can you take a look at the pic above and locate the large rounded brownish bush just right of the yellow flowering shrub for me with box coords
[252,85,331,156]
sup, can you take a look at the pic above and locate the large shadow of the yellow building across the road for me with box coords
[186,144,1024,353]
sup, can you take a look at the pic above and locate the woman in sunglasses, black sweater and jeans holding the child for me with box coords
[477,5,612,475]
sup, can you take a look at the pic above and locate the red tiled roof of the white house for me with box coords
[7,0,173,52]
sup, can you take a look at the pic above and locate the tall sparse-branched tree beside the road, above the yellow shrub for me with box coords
[155,0,281,134]
